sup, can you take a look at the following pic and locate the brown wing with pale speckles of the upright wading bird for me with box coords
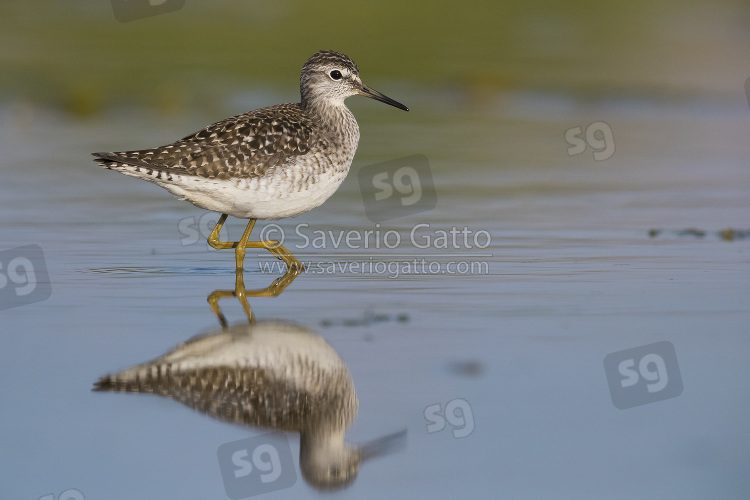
[94,104,316,179]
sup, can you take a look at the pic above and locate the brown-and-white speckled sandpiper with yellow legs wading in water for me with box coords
[93,50,409,269]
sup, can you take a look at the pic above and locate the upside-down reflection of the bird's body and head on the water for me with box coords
[94,321,404,488]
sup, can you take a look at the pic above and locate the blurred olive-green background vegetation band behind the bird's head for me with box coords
[0,0,750,116]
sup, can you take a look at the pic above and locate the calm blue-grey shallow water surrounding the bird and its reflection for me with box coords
[0,1,750,499]
